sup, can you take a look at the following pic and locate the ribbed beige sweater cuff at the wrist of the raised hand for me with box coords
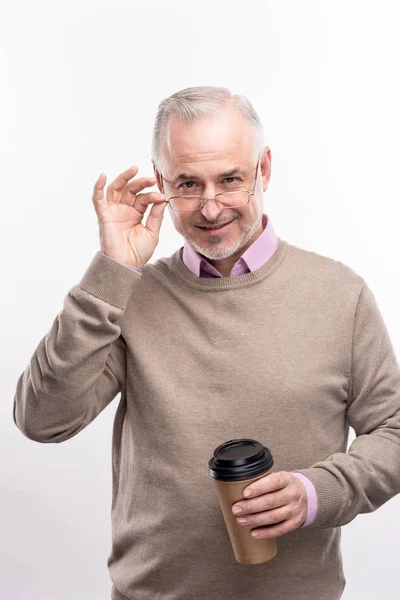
[78,250,142,311]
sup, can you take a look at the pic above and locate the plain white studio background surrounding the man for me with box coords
[0,0,400,600]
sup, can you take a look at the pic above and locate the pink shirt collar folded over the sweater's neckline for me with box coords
[181,213,279,277]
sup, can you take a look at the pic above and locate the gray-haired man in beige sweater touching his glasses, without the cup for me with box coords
[14,87,400,600]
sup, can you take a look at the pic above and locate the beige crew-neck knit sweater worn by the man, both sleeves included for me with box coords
[14,240,400,600]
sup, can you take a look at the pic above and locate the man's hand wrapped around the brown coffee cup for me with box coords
[232,471,308,539]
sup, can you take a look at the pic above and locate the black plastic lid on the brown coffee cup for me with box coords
[208,438,274,481]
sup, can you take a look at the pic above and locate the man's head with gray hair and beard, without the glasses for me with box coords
[152,86,271,260]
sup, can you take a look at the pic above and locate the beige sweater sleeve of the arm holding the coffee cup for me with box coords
[297,282,400,529]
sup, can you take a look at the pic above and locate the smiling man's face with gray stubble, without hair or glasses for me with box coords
[154,108,271,260]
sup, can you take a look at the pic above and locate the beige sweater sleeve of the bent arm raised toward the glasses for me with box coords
[13,251,141,442]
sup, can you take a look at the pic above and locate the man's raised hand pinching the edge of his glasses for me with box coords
[92,166,168,269]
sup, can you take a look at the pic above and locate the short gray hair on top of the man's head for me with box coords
[151,85,264,165]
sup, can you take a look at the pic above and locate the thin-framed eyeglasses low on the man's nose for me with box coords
[160,155,261,212]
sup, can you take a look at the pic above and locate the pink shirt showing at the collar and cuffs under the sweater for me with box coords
[103,214,318,527]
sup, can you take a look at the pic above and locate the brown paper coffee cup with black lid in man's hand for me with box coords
[208,438,277,565]
